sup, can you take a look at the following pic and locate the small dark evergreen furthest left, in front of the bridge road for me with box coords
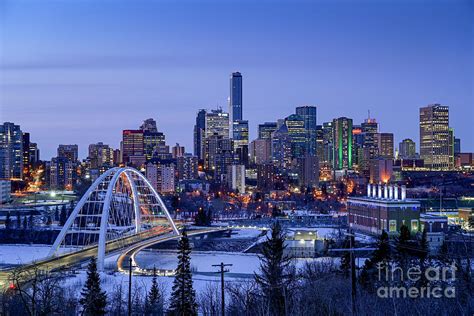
[79,258,107,315]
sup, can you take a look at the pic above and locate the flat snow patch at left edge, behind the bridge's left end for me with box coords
[0,244,77,265]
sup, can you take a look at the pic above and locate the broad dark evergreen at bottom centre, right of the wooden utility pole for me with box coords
[255,221,292,315]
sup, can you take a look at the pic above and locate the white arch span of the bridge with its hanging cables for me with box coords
[49,167,179,270]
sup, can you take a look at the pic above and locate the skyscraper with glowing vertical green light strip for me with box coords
[332,117,352,170]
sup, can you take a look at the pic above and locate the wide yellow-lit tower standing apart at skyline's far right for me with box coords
[420,104,454,170]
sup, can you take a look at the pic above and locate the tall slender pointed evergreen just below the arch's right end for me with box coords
[168,230,197,316]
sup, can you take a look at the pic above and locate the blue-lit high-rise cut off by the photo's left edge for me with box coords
[0,122,23,180]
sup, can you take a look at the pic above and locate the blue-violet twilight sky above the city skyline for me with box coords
[0,0,474,159]
